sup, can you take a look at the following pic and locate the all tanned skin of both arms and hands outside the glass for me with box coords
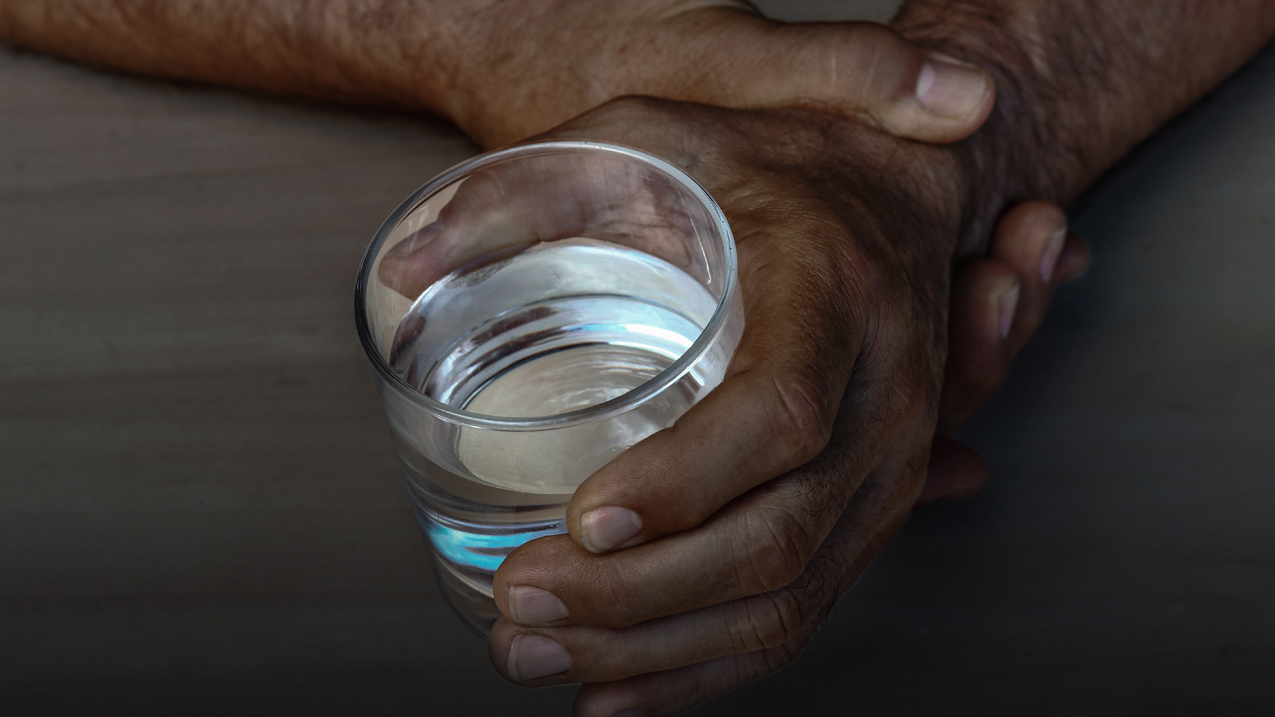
[0,0,1254,714]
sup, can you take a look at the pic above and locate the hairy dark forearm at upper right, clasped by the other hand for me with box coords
[894,0,1275,253]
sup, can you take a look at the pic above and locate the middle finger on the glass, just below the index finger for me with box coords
[493,476,856,628]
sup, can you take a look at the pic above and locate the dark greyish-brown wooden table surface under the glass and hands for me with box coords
[0,3,1275,716]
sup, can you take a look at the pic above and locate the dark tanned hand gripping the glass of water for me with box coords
[474,100,1082,714]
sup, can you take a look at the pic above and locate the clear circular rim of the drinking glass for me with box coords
[354,140,738,431]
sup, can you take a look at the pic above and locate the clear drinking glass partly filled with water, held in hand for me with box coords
[354,142,743,633]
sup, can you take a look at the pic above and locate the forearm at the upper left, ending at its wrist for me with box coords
[0,0,485,116]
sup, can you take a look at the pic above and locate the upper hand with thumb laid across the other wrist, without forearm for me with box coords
[450,0,995,147]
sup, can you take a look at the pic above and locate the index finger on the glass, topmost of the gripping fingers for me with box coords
[566,228,882,552]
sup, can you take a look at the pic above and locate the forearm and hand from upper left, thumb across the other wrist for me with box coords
[0,0,1009,147]
